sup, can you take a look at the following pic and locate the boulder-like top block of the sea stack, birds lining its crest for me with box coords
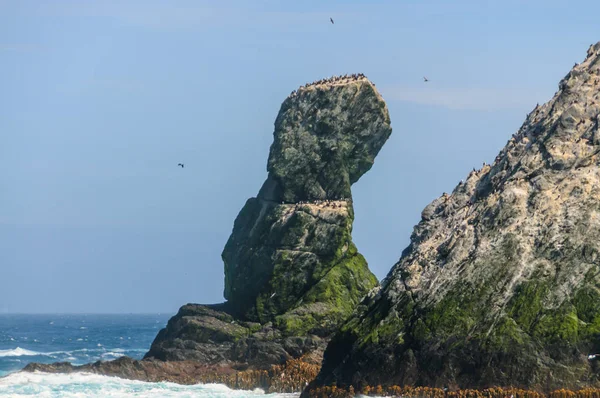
[260,77,391,203]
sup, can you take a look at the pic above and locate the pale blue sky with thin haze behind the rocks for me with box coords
[0,0,600,313]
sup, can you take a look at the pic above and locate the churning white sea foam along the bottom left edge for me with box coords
[0,372,299,398]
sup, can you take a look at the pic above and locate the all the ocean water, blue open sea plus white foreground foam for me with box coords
[0,314,297,398]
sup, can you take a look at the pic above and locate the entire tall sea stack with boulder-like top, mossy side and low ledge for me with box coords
[146,75,391,368]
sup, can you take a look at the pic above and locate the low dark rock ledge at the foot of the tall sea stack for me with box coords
[145,304,327,370]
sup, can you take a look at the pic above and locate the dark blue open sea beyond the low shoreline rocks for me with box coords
[0,314,169,376]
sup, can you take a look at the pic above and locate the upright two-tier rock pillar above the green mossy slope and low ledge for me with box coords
[222,77,391,322]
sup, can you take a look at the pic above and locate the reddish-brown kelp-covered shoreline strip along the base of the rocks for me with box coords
[23,357,600,398]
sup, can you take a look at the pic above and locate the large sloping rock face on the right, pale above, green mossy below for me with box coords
[312,43,600,391]
